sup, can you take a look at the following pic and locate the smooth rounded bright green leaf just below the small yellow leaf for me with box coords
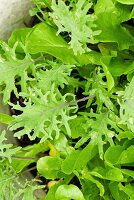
[37,156,62,179]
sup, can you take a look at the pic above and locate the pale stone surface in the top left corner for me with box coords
[0,0,32,40]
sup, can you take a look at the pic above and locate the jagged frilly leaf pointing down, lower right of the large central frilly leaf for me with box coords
[81,112,116,159]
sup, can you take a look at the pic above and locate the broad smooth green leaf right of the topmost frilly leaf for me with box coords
[94,0,134,50]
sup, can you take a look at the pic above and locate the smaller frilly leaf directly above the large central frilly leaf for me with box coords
[35,61,75,93]
